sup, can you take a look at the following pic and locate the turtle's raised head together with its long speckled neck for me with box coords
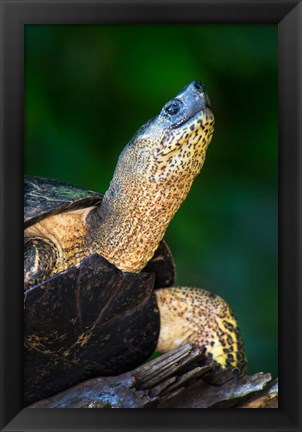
[98,81,214,272]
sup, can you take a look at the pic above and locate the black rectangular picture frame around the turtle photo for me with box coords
[0,0,302,431]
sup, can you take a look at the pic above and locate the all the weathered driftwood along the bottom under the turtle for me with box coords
[30,344,278,408]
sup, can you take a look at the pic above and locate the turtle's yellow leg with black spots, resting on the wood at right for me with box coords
[155,287,246,372]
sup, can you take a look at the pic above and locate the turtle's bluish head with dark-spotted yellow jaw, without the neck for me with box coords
[121,81,214,182]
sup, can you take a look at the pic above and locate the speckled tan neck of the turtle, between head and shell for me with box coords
[93,174,193,272]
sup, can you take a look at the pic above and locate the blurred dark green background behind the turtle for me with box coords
[24,25,278,375]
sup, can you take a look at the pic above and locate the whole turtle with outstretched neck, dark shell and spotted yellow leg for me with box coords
[24,80,246,404]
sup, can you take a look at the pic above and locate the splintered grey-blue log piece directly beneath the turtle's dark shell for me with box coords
[31,344,212,408]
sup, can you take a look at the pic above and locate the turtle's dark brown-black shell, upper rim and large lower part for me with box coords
[24,177,175,405]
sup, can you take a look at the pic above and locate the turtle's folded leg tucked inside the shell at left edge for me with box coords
[24,238,58,288]
